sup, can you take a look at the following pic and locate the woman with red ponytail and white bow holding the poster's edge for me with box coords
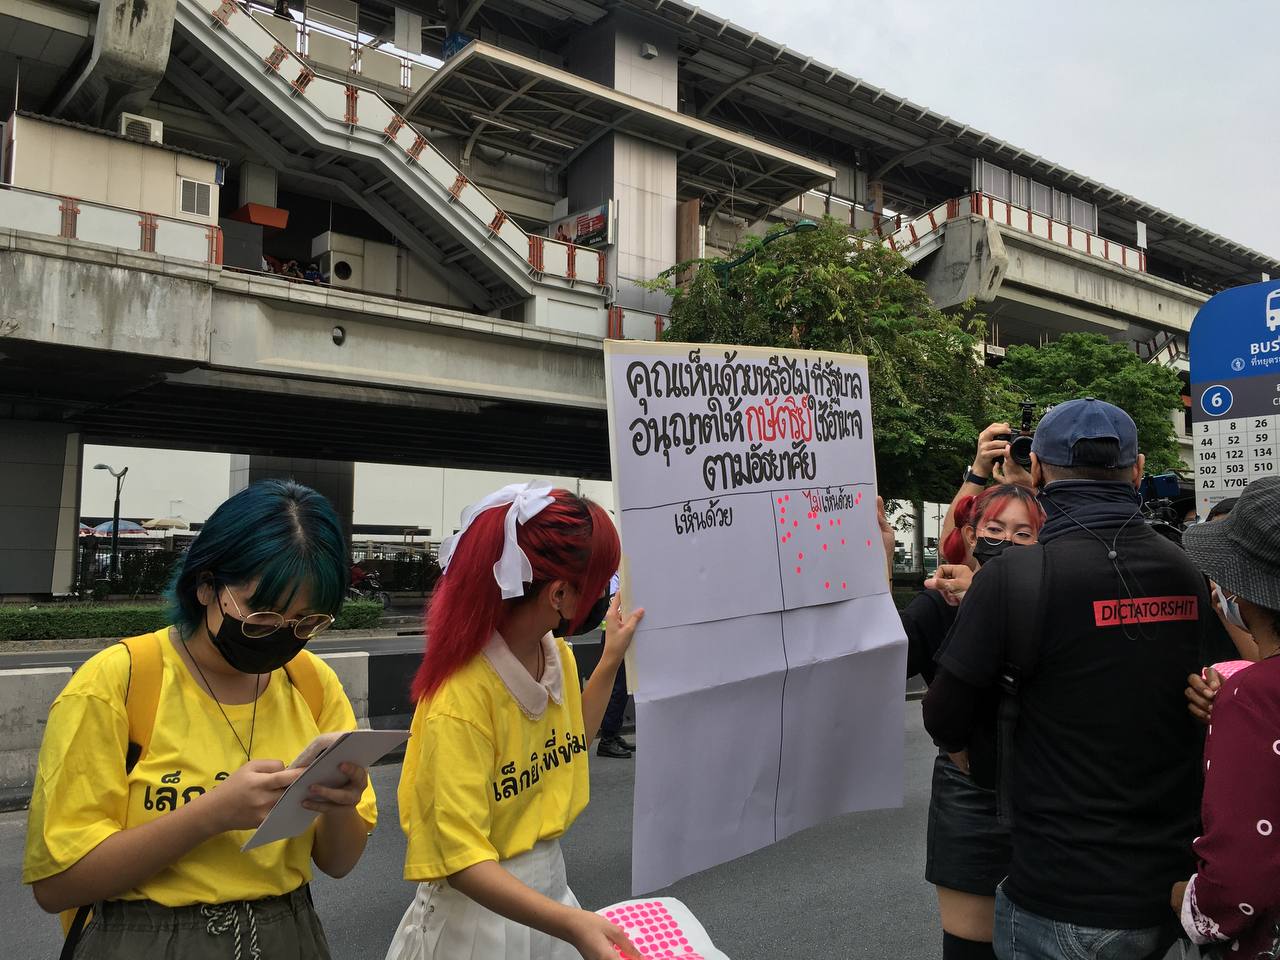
[387,484,644,960]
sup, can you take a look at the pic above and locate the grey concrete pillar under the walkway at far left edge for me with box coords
[0,420,81,596]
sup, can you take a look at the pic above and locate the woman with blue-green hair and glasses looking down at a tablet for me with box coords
[23,480,378,960]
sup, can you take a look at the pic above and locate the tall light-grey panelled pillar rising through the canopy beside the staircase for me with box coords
[566,12,678,314]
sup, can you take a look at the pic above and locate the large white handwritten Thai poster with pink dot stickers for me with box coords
[605,340,906,895]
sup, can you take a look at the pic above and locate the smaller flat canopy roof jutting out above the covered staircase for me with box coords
[404,42,836,216]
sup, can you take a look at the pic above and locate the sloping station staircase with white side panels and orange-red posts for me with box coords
[166,0,608,325]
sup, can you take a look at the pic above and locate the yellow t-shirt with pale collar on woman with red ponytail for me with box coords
[399,635,589,881]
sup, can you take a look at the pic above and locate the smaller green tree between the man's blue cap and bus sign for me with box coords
[1000,333,1185,474]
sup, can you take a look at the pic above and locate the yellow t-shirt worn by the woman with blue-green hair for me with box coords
[22,630,378,906]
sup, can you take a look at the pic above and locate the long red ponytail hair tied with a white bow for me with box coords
[412,490,621,701]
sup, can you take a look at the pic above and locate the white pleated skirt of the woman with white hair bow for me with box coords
[387,840,581,960]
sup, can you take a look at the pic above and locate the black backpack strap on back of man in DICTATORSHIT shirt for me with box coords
[996,544,1044,826]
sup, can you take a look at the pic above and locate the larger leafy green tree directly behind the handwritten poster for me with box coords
[649,218,1001,502]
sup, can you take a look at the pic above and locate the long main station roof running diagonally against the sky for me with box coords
[369,0,1280,287]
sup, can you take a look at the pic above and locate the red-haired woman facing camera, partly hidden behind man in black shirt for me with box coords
[902,484,1044,960]
